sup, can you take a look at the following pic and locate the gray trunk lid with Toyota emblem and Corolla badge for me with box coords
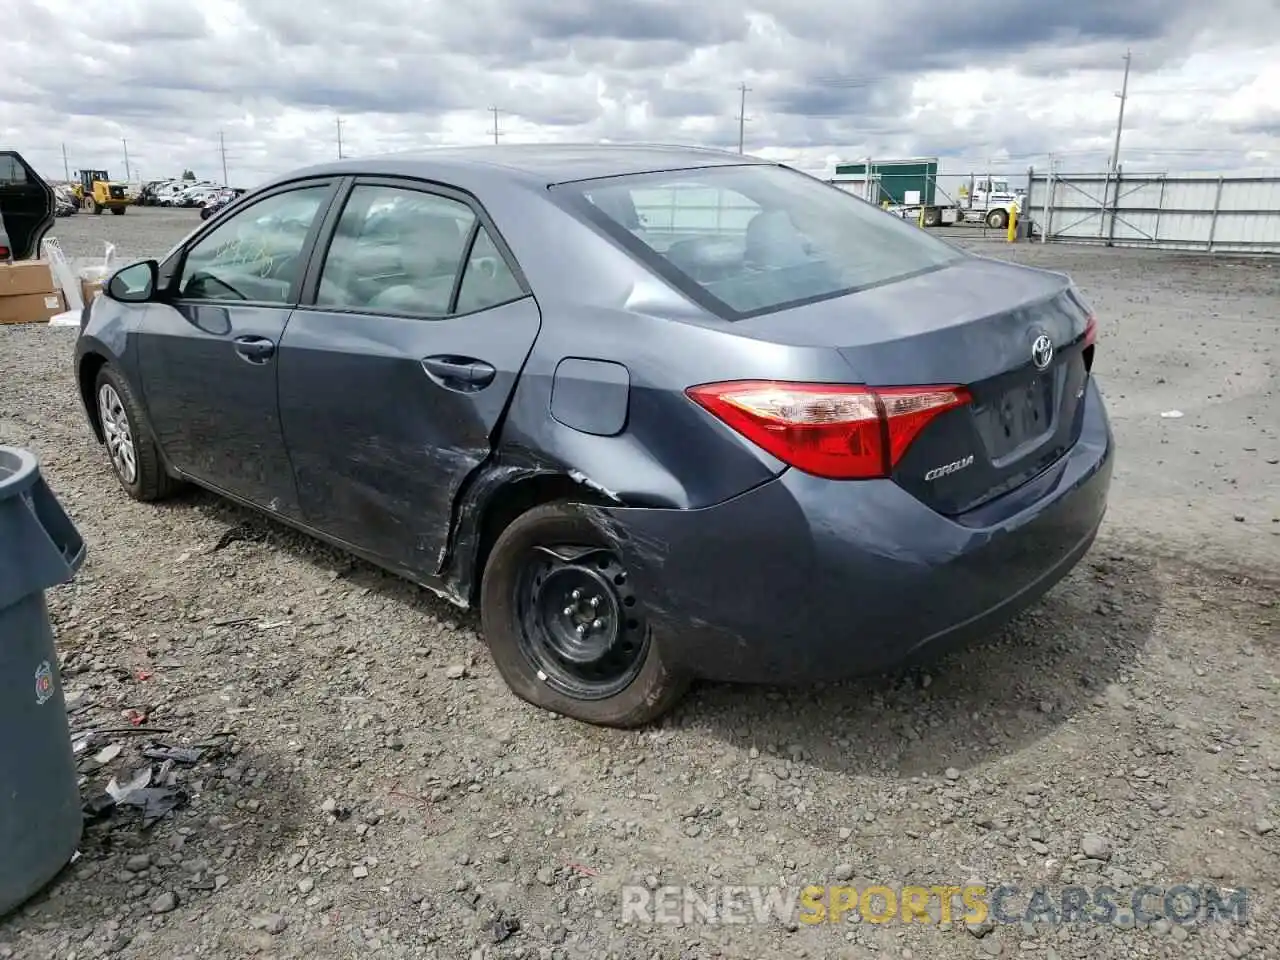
[735,257,1092,516]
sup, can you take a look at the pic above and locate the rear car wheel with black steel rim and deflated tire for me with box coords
[480,503,689,728]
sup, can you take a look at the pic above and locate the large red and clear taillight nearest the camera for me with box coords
[686,380,970,480]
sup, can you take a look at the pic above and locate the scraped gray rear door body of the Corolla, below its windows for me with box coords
[279,298,540,577]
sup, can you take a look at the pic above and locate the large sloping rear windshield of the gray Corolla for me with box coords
[559,164,966,319]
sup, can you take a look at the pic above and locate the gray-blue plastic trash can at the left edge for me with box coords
[0,447,84,916]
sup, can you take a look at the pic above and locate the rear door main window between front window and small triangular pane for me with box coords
[316,184,476,317]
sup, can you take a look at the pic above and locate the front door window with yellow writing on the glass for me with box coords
[178,184,329,305]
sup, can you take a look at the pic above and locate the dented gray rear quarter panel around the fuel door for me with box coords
[476,180,849,509]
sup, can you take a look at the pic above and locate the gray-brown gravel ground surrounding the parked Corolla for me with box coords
[0,210,1280,960]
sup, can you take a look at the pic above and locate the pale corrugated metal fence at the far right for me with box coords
[1027,170,1280,253]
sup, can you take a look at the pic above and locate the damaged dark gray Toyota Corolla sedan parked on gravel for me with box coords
[76,146,1112,726]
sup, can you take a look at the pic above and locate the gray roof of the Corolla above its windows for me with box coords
[266,143,772,187]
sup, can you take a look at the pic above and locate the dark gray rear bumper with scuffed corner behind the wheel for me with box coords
[600,380,1114,682]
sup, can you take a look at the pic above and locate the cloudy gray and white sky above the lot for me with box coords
[0,0,1280,187]
